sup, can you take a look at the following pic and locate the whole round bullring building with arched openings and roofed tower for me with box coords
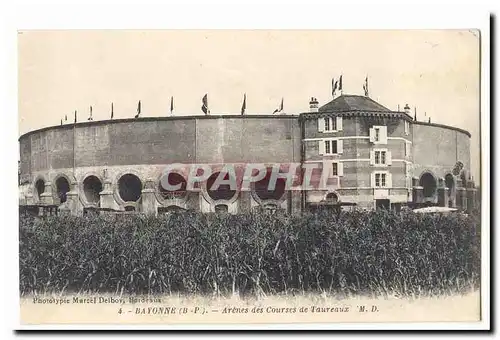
[19,95,477,214]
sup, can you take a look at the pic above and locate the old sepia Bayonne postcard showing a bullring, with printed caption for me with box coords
[17,28,487,328]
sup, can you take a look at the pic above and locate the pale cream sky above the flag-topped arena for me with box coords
[18,30,480,178]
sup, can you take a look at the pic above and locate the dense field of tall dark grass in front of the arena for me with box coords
[20,211,480,296]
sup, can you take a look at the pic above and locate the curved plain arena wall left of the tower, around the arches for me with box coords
[19,116,301,212]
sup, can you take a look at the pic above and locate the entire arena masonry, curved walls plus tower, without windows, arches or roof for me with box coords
[19,114,472,212]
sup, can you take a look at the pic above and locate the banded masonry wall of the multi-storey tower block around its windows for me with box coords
[303,113,413,207]
